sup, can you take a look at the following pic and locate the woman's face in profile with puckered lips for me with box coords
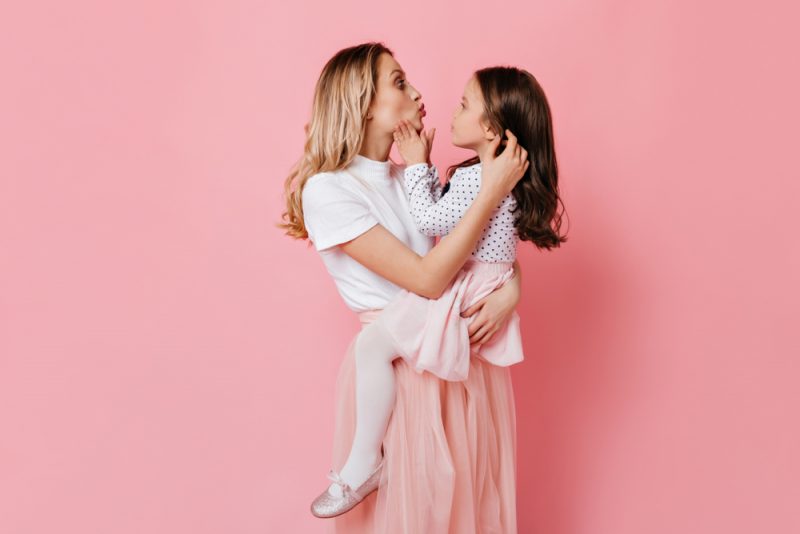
[368,52,426,134]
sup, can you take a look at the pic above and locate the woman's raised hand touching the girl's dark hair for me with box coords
[478,130,530,204]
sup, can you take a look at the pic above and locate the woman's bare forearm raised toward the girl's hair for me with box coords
[421,194,497,298]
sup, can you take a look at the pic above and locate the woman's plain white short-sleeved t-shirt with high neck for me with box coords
[302,154,435,312]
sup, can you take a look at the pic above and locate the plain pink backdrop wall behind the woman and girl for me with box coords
[0,0,800,534]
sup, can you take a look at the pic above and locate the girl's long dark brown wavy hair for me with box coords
[447,67,567,250]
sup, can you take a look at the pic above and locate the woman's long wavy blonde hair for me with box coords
[277,43,394,239]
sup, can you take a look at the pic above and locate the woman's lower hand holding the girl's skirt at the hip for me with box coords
[461,261,522,350]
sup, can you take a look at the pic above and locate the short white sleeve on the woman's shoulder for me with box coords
[303,175,378,251]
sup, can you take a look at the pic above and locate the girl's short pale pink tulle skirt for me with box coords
[376,259,524,380]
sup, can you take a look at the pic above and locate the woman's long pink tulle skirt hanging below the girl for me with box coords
[325,310,517,534]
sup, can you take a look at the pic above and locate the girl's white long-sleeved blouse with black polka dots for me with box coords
[403,163,519,263]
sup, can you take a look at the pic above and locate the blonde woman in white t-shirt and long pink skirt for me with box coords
[281,43,524,534]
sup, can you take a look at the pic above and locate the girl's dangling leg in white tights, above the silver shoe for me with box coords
[329,322,398,496]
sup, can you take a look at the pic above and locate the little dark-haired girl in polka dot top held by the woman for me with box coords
[311,67,566,517]
